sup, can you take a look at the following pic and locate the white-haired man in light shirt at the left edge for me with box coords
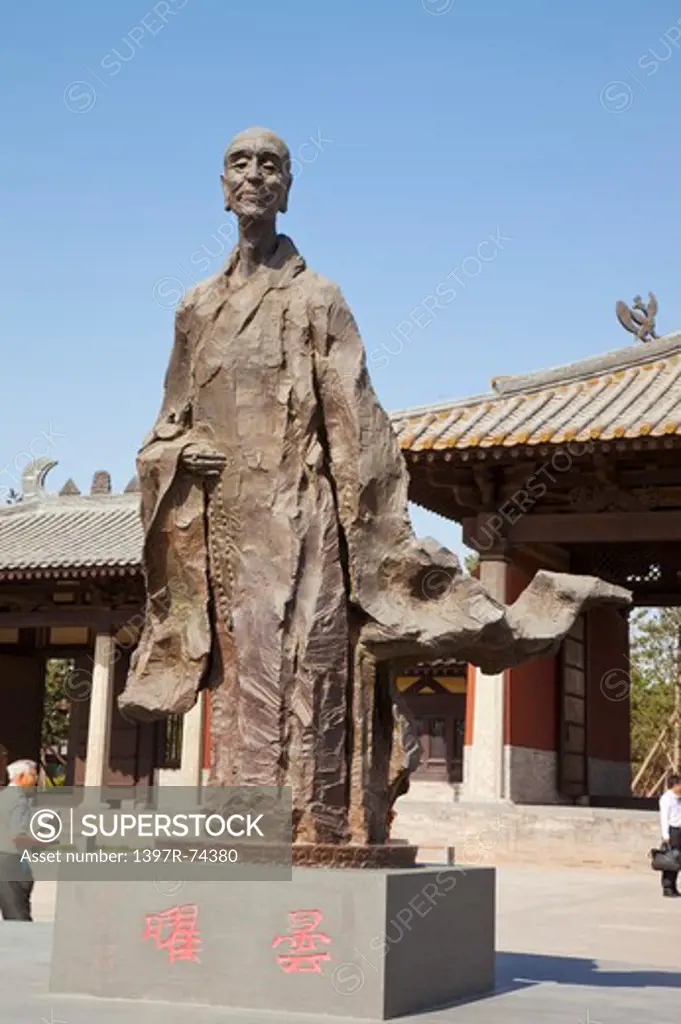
[0,761,38,921]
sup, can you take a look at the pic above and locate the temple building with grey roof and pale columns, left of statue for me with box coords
[0,459,186,786]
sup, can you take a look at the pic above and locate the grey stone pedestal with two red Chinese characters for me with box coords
[50,867,495,1020]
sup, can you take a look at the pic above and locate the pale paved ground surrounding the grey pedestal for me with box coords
[0,867,681,1024]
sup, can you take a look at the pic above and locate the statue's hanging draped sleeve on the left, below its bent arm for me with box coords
[119,293,211,718]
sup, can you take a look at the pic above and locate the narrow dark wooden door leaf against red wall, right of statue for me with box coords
[558,616,588,800]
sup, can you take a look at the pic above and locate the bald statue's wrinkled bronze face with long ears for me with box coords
[221,132,291,220]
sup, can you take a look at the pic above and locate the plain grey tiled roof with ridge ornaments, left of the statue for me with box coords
[0,466,142,572]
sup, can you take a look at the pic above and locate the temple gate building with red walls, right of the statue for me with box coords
[393,334,681,804]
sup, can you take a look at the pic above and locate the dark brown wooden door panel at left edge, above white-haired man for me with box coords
[0,652,45,763]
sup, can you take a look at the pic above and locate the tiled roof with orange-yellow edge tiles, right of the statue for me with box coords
[391,333,681,452]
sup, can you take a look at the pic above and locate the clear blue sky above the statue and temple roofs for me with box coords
[0,0,681,561]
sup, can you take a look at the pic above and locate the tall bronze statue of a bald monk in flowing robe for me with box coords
[121,129,628,845]
